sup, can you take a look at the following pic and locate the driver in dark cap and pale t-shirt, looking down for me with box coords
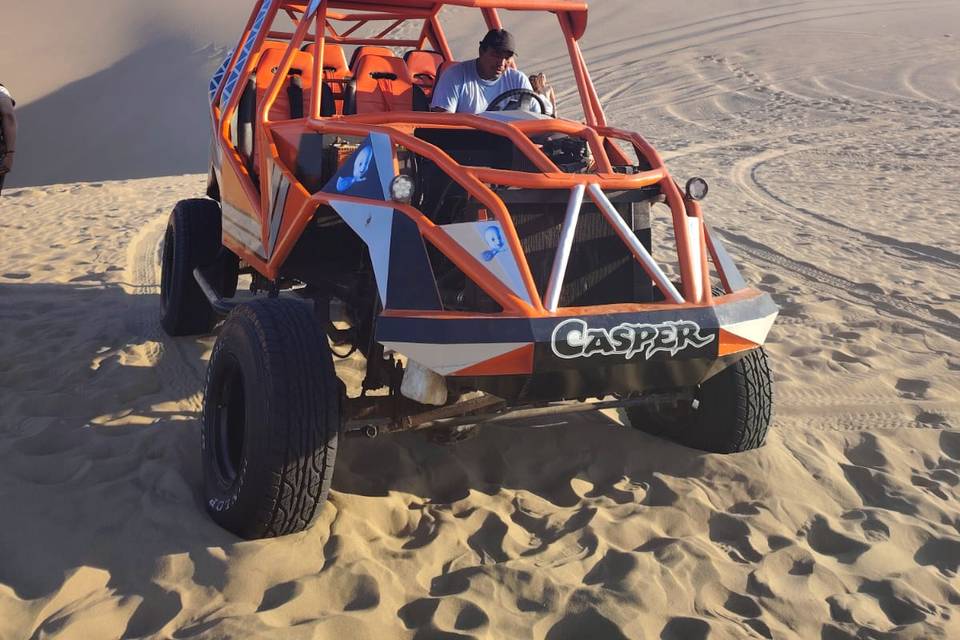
[430,29,533,114]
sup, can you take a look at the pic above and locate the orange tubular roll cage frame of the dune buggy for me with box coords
[212,0,729,316]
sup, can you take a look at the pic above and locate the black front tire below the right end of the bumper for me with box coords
[625,347,773,453]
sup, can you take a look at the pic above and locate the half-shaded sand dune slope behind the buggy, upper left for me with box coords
[0,0,249,186]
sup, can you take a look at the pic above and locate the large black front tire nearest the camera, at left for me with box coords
[202,298,341,539]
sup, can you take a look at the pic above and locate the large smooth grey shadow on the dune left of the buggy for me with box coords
[6,38,226,188]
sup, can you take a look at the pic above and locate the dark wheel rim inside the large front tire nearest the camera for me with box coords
[212,358,246,485]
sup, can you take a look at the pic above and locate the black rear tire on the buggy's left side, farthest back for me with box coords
[160,198,229,336]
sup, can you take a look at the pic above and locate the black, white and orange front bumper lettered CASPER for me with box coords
[377,289,778,401]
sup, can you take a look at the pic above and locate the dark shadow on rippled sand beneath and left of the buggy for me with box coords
[0,282,703,637]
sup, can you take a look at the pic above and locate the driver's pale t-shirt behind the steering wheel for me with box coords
[430,60,533,113]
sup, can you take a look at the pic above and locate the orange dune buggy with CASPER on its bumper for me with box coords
[161,0,777,538]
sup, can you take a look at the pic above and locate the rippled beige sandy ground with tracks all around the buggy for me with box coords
[0,0,960,640]
